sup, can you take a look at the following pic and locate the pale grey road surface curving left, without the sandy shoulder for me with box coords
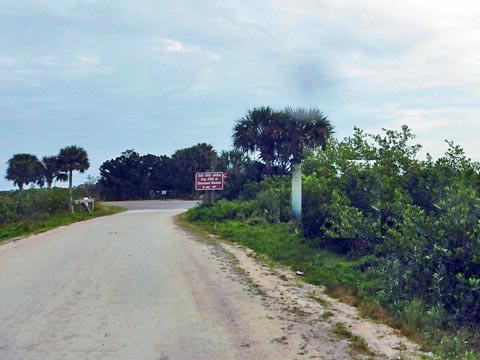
[0,201,297,360]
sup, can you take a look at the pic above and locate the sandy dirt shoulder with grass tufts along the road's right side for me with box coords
[177,217,428,359]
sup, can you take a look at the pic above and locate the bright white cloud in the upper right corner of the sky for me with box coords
[330,0,480,95]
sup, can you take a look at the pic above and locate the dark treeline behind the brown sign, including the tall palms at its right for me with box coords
[98,107,333,200]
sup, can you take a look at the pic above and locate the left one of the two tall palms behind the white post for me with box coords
[232,106,279,174]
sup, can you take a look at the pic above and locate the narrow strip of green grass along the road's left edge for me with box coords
[0,206,125,244]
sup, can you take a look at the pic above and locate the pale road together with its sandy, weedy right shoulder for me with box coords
[0,201,415,360]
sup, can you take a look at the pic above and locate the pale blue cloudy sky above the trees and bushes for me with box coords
[0,0,480,190]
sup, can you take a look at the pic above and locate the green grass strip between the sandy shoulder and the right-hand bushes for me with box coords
[179,209,480,360]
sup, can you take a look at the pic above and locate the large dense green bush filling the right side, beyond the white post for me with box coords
[302,127,480,324]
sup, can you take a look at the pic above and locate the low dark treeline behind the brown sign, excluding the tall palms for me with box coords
[97,143,265,200]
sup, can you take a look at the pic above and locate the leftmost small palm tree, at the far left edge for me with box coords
[5,154,43,191]
